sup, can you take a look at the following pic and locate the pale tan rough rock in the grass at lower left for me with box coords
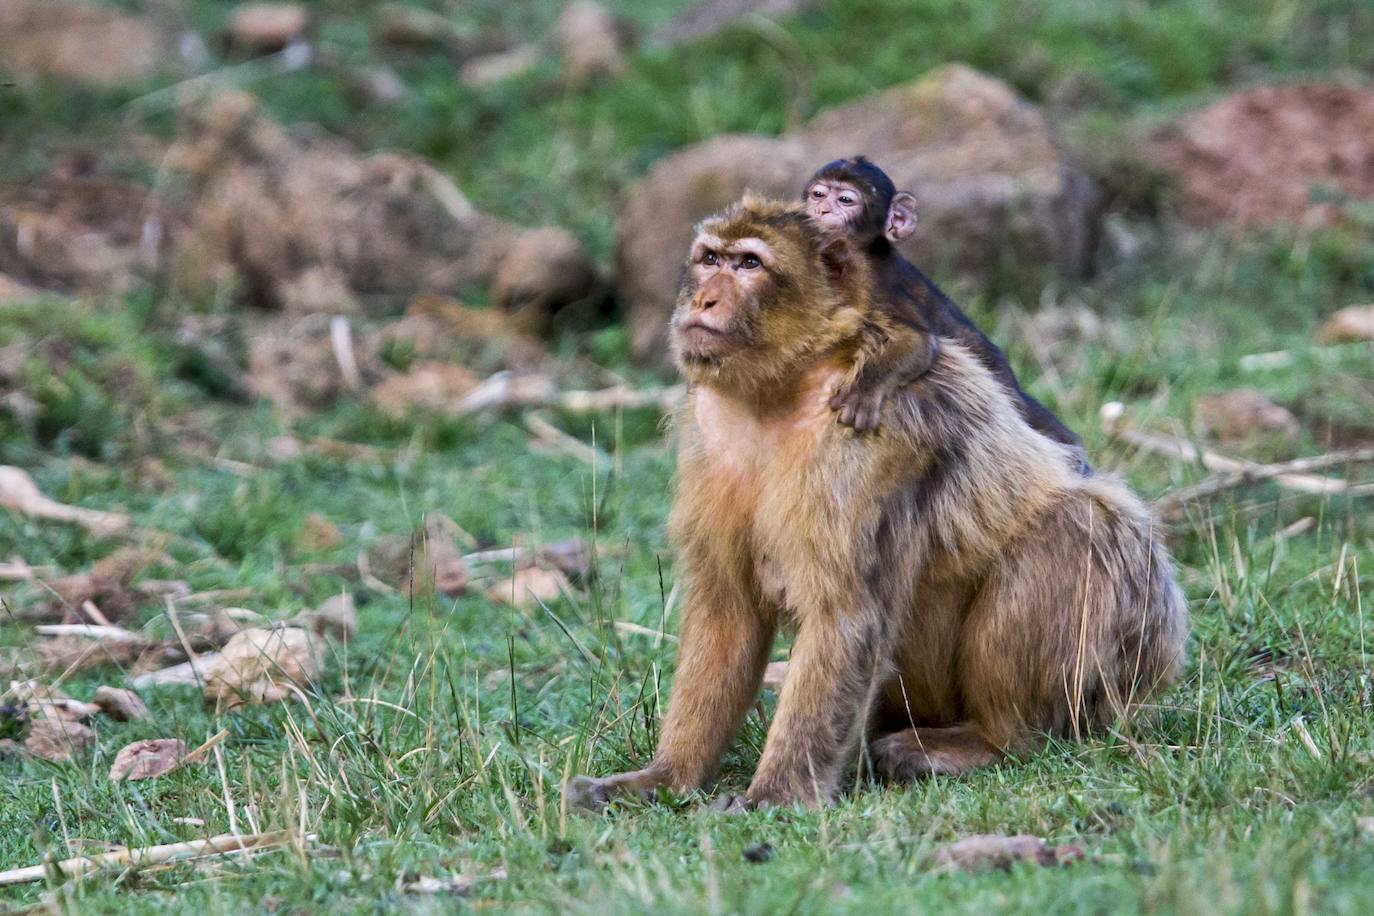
[205,626,324,710]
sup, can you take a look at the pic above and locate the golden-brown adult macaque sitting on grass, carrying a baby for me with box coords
[566,199,1186,808]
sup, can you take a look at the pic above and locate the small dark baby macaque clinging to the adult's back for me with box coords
[802,157,1087,468]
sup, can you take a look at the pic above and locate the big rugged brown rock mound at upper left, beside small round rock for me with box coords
[168,92,518,312]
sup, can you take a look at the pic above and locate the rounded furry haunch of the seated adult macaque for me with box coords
[959,478,1187,751]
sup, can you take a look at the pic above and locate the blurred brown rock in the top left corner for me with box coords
[0,0,172,87]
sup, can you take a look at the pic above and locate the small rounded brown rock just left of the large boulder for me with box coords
[492,227,598,334]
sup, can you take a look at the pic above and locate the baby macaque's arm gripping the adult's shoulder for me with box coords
[830,325,940,433]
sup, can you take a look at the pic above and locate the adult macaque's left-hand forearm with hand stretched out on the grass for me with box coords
[563,577,776,809]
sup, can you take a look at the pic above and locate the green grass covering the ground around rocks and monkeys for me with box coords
[0,0,1374,913]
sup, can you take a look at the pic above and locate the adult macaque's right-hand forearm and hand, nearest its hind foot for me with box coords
[747,610,889,808]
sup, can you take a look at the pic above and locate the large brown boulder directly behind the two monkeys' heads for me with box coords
[616,65,1101,357]
